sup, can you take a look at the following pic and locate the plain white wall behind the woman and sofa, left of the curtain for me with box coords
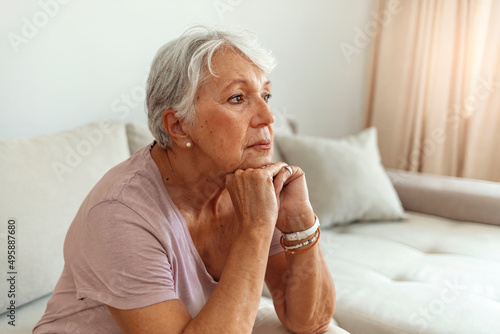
[0,0,373,138]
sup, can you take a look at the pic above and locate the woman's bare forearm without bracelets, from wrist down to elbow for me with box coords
[184,228,272,333]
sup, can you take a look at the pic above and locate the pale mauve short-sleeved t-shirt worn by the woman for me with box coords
[33,145,282,334]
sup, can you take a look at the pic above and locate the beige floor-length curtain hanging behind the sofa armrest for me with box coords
[366,0,500,181]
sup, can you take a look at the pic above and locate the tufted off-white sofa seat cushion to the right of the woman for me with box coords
[320,212,500,334]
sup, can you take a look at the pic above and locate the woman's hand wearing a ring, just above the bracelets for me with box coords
[273,166,314,233]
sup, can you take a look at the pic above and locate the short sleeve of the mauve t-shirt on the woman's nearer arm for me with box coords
[65,201,178,309]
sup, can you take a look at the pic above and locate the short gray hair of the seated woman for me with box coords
[146,27,275,149]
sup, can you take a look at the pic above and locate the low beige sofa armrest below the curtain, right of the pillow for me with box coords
[386,168,500,225]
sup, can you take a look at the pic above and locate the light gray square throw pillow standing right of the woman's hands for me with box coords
[276,128,404,227]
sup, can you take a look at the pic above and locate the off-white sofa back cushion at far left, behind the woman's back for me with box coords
[0,121,129,310]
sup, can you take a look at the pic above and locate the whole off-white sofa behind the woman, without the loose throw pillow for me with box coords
[0,121,500,334]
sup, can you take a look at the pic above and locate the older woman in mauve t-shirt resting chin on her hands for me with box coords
[34,29,335,334]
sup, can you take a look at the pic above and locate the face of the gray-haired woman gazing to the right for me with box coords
[188,50,274,172]
